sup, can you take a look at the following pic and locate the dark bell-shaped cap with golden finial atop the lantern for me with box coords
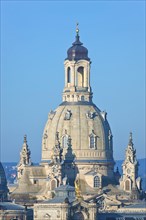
[66,24,90,61]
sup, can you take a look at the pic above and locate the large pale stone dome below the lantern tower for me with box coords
[42,101,113,162]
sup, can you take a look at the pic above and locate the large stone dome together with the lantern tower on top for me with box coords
[42,24,114,181]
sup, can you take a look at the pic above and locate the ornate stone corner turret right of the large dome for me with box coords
[120,133,141,197]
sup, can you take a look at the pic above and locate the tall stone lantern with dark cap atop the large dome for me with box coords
[63,24,92,102]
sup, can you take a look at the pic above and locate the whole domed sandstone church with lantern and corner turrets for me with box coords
[11,26,146,220]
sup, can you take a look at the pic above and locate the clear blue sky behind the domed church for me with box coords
[1,0,146,162]
